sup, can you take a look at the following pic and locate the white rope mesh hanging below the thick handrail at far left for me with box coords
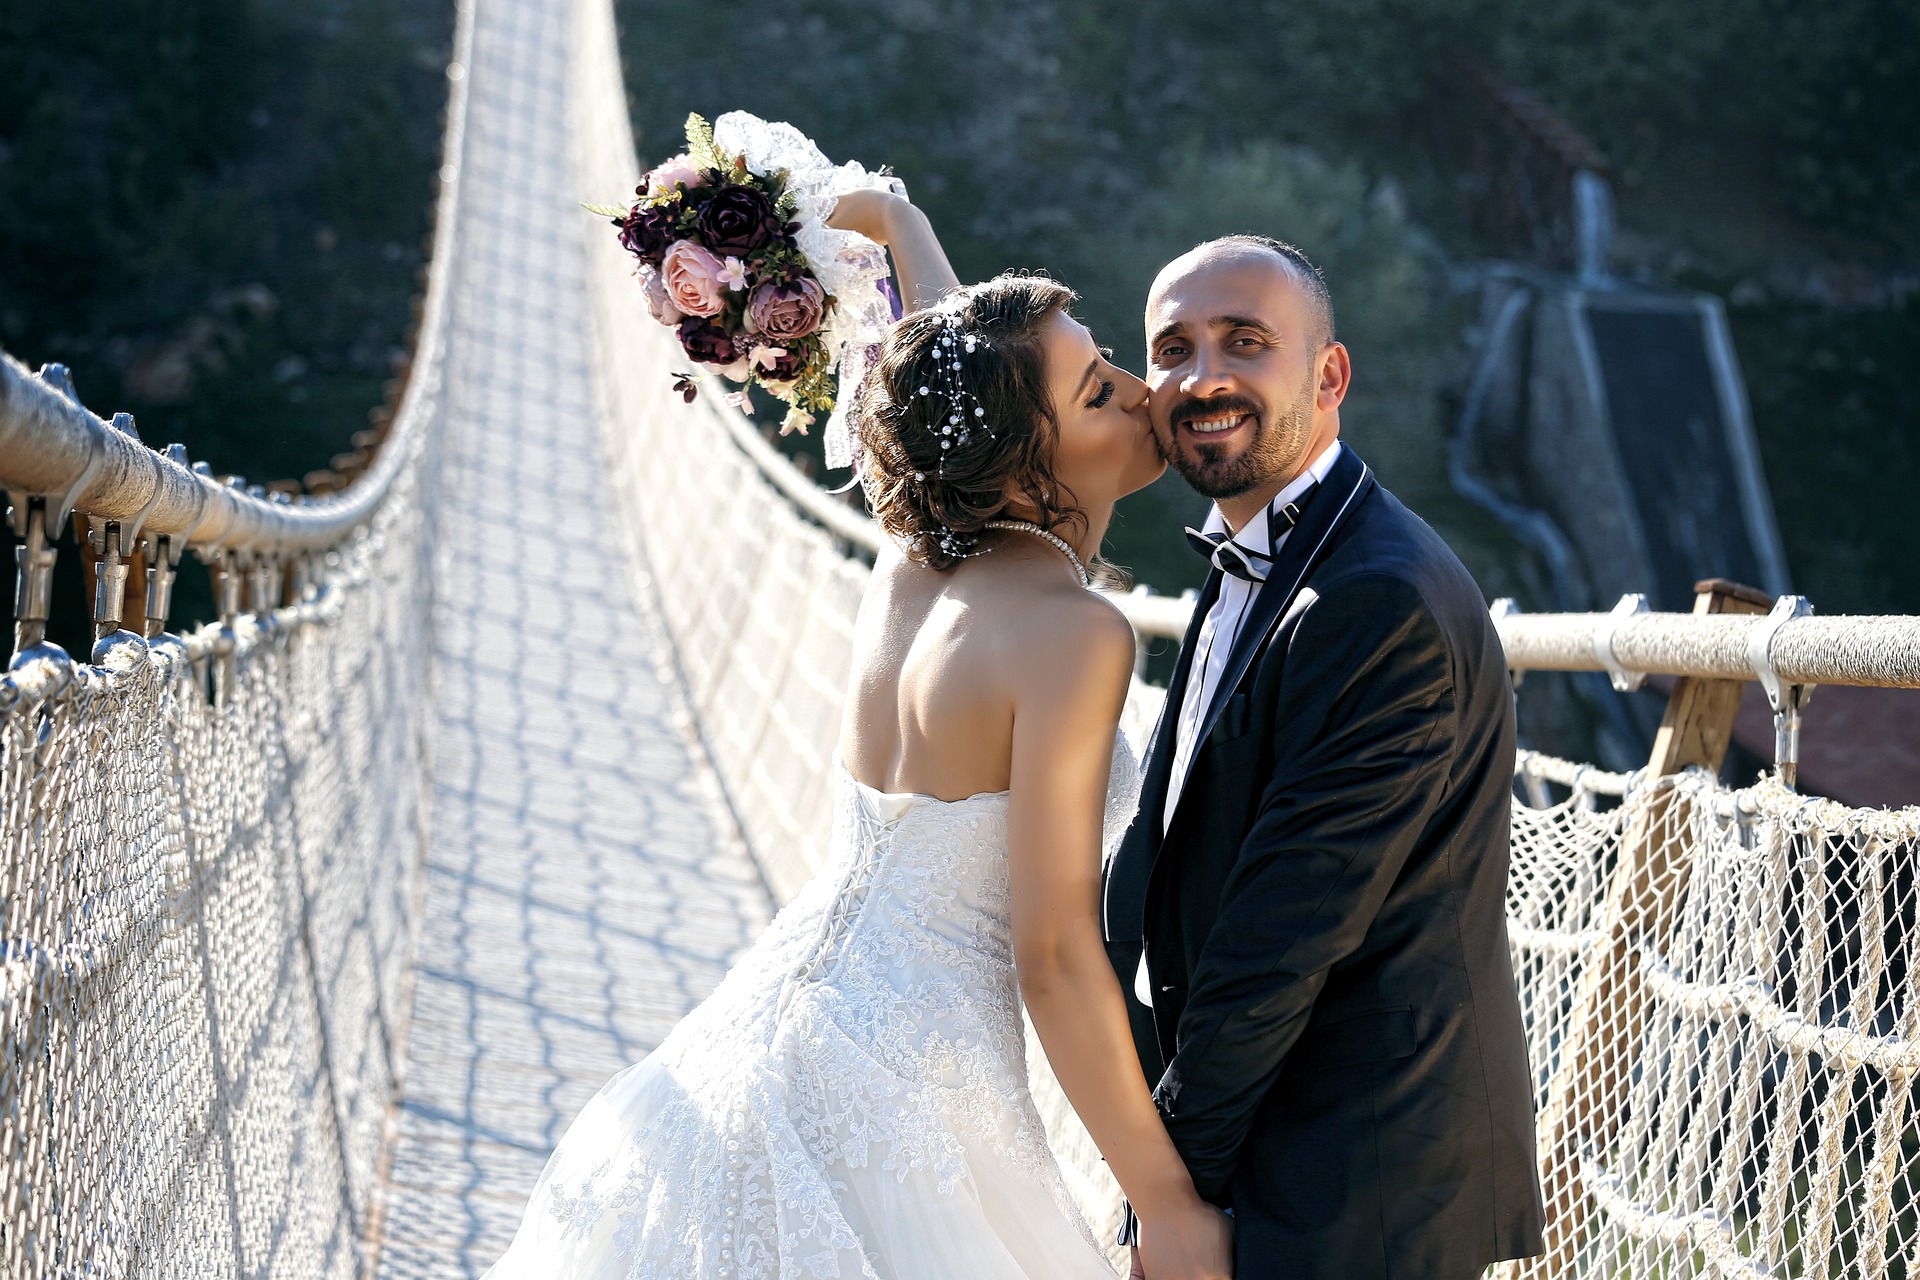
[0,427,426,1278]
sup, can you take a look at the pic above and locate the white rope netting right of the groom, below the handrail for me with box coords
[1509,760,1920,1280]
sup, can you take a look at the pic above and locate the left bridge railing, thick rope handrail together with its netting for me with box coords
[0,0,467,1280]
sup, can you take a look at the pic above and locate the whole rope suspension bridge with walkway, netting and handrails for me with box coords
[0,0,1920,1278]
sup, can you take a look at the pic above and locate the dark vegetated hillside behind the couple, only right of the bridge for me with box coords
[614,0,1920,612]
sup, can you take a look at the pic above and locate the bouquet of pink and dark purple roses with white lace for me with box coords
[588,111,904,466]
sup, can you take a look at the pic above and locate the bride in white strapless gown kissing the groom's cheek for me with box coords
[488,192,1229,1280]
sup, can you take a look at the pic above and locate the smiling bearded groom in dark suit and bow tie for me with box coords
[1104,236,1542,1280]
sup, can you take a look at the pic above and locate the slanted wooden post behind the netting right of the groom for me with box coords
[1517,578,1772,1280]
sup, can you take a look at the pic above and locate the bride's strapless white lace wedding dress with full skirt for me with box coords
[488,737,1140,1280]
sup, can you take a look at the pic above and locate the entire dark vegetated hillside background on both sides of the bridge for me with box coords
[0,0,1920,641]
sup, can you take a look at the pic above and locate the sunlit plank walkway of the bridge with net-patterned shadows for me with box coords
[368,0,772,1280]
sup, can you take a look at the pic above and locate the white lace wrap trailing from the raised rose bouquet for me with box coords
[714,111,906,466]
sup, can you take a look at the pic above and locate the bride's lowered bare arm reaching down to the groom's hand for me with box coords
[1008,595,1229,1280]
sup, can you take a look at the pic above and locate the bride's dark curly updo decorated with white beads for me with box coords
[852,271,1083,570]
